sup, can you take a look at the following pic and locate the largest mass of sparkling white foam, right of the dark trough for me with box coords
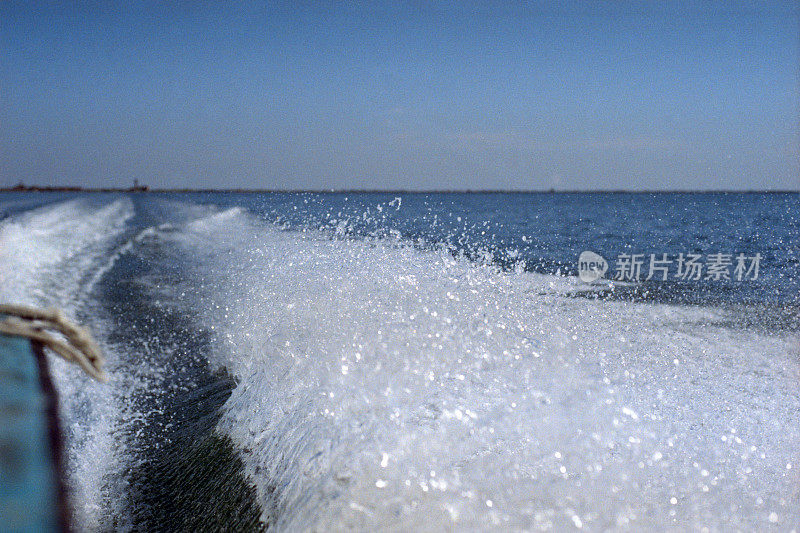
[173,206,800,530]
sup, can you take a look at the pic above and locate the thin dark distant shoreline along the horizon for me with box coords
[0,185,800,194]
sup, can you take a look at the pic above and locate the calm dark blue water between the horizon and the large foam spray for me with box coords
[166,193,800,305]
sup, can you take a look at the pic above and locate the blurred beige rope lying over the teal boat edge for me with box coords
[0,304,108,382]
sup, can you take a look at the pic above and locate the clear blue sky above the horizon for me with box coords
[0,1,800,190]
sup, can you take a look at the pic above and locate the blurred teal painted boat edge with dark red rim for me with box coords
[0,335,68,532]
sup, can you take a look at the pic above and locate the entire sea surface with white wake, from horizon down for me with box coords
[0,193,800,531]
